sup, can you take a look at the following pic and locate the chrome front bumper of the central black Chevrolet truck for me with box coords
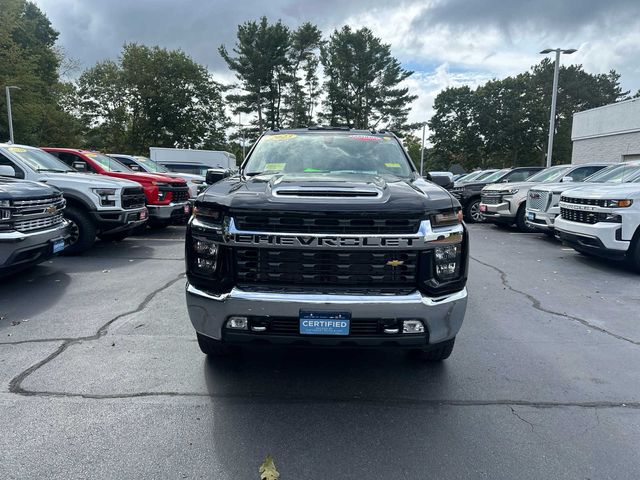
[186,283,467,344]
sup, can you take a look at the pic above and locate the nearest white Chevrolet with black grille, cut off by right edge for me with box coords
[555,175,640,271]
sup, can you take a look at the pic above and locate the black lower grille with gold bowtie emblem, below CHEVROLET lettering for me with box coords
[235,248,418,293]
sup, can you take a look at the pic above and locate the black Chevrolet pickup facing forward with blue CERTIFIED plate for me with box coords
[186,127,469,361]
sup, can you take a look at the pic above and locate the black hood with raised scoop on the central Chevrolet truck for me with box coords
[198,173,459,215]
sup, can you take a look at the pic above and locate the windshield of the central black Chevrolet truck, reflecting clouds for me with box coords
[244,132,412,177]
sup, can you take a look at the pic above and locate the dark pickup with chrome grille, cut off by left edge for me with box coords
[0,176,70,277]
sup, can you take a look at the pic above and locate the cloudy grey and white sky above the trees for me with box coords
[35,0,640,132]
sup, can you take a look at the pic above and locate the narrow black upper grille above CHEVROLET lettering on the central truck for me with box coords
[231,210,420,235]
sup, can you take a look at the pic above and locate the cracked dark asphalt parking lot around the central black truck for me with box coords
[0,225,640,480]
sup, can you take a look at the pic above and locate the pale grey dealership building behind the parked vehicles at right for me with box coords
[571,98,640,164]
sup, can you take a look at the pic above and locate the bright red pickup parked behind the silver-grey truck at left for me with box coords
[42,147,190,227]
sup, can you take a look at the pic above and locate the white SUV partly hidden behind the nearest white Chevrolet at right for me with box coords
[526,162,640,236]
